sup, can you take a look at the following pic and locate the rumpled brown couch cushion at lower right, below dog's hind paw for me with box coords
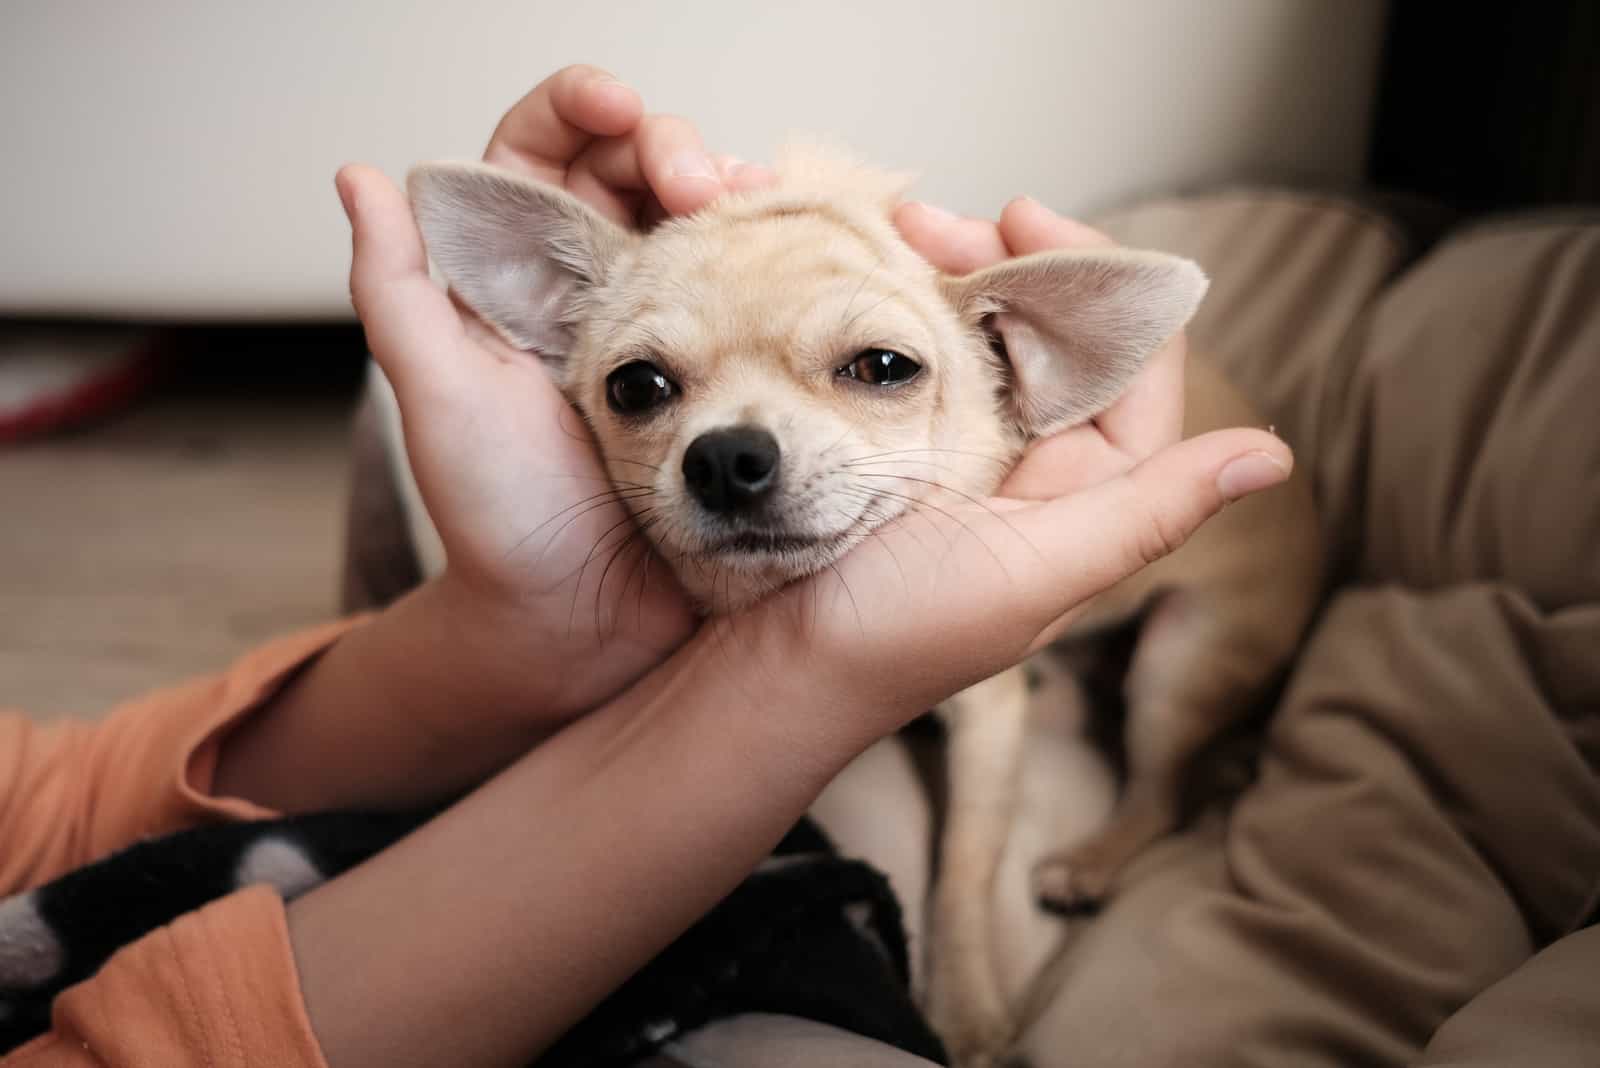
[1024,585,1600,1068]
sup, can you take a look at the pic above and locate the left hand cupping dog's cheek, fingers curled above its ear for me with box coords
[338,66,773,718]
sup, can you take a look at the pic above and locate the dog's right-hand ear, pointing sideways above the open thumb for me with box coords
[946,249,1208,438]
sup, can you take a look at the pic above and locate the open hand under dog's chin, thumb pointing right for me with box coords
[726,415,1293,758]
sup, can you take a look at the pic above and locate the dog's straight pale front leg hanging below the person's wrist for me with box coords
[928,668,1027,1068]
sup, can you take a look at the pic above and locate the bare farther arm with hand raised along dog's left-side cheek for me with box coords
[214,66,771,812]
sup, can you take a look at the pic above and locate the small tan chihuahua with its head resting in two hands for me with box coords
[389,147,1320,1065]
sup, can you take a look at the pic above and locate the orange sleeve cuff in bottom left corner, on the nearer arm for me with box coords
[0,887,328,1068]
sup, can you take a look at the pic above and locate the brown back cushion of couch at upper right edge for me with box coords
[1317,216,1600,609]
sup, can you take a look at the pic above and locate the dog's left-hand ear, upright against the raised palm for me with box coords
[406,163,635,368]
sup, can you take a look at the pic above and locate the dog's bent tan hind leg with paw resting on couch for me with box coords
[1034,592,1277,908]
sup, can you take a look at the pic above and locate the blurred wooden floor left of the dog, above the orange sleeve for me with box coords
[0,331,358,716]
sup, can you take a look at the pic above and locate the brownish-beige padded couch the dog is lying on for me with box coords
[349,190,1600,1068]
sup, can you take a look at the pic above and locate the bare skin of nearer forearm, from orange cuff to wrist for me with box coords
[290,629,862,1068]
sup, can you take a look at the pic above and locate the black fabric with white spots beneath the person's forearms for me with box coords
[0,812,944,1068]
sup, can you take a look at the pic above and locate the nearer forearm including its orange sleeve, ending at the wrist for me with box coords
[5,641,838,1068]
